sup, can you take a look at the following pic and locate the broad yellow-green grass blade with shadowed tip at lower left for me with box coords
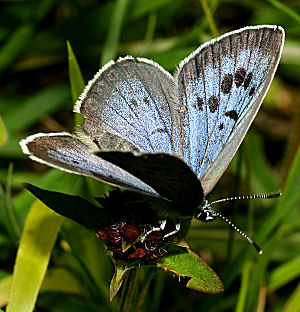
[6,201,63,312]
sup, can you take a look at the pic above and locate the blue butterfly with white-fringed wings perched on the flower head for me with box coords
[20,25,285,252]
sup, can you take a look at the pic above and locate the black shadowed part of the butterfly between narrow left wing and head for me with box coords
[96,151,203,215]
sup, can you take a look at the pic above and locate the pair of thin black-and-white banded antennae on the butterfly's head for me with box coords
[210,193,282,255]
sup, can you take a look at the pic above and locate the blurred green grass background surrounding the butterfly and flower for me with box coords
[0,0,300,312]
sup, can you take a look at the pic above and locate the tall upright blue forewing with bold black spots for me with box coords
[175,25,284,194]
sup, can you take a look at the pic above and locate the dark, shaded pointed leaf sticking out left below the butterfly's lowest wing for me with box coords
[24,184,108,232]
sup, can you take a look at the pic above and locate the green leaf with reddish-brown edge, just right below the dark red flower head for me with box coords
[157,241,223,294]
